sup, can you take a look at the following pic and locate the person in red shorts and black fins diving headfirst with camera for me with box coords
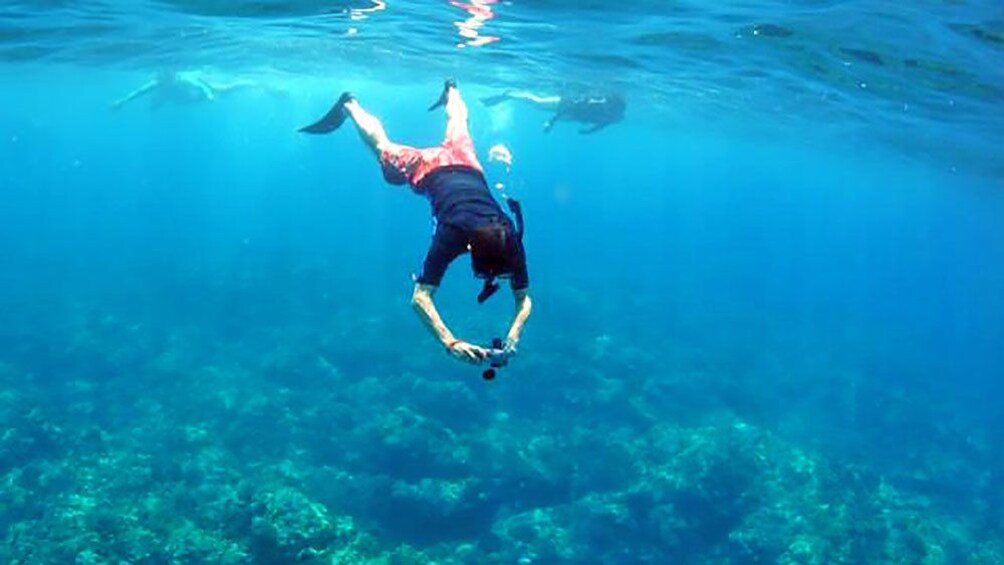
[300,79,531,367]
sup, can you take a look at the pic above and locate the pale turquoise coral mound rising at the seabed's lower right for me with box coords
[492,417,1000,564]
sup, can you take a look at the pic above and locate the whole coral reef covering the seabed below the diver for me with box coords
[0,295,1004,565]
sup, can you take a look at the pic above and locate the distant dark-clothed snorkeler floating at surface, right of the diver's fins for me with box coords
[481,90,628,133]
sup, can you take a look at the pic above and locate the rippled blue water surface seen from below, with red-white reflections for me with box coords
[0,0,1004,172]
